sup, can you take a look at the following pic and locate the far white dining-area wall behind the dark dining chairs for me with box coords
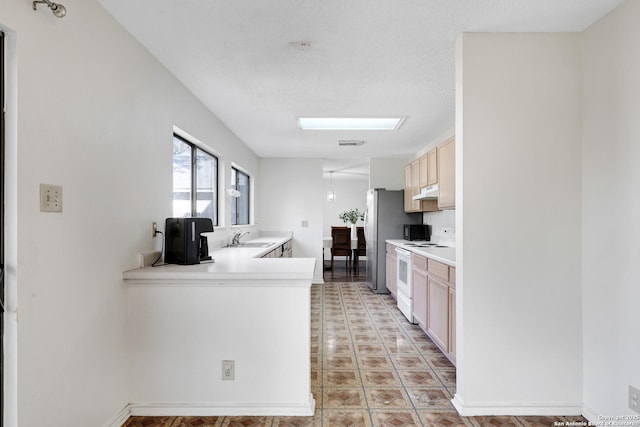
[322,173,369,237]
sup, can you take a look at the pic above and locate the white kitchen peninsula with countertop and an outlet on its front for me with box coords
[123,236,315,415]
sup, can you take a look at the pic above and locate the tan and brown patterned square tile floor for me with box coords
[124,282,586,427]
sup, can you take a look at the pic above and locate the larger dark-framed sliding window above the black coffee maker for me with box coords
[173,135,218,225]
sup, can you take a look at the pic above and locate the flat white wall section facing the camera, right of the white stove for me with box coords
[455,34,582,415]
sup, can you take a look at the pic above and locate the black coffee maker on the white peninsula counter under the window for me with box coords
[164,218,213,265]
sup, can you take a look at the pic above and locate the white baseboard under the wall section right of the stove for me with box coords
[451,393,583,417]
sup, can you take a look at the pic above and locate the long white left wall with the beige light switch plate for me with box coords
[0,0,260,427]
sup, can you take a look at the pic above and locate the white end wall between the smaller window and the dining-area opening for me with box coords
[256,158,326,283]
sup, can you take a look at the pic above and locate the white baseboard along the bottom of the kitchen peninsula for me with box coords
[126,395,316,420]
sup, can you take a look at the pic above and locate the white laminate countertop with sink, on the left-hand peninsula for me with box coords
[122,236,316,284]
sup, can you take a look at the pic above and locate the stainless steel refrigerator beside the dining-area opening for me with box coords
[364,188,422,294]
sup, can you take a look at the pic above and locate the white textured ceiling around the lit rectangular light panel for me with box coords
[99,0,622,165]
